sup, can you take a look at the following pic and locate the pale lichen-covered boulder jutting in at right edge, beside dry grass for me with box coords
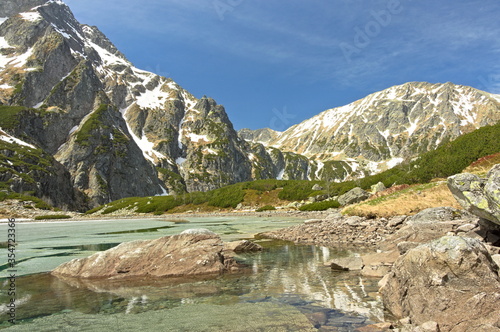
[448,164,500,225]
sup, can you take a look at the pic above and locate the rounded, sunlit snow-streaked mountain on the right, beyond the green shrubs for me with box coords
[269,82,500,171]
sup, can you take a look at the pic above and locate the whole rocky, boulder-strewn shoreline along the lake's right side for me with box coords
[259,165,500,332]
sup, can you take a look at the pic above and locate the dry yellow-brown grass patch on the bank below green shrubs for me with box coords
[342,182,461,218]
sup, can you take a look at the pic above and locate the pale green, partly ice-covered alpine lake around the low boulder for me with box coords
[0,216,384,332]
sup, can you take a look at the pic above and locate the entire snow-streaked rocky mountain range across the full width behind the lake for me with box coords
[0,0,500,207]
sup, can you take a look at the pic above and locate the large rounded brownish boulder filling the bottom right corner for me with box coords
[380,236,500,332]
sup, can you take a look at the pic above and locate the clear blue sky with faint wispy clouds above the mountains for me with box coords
[65,0,500,130]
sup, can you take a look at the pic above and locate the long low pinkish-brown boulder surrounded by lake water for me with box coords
[52,230,242,279]
